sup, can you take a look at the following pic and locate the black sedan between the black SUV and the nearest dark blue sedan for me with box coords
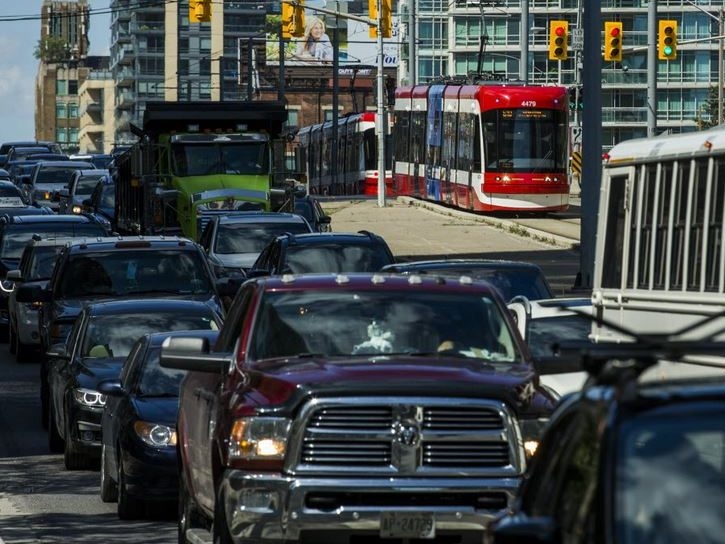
[48,299,221,470]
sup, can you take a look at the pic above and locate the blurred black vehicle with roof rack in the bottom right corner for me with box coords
[487,340,725,544]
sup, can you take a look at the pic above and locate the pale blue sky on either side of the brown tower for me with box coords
[0,0,111,142]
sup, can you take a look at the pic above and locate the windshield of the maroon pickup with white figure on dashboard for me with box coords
[250,290,520,364]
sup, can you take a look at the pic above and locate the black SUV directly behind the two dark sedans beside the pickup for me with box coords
[15,236,225,424]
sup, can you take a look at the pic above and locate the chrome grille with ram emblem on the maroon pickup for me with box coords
[290,398,523,476]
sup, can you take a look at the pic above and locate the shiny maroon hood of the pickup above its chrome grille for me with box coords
[243,356,555,412]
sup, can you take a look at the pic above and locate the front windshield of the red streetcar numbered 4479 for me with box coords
[482,109,568,173]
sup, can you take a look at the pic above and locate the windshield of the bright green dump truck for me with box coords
[173,142,270,177]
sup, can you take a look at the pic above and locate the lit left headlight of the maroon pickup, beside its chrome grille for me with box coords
[229,417,291,461]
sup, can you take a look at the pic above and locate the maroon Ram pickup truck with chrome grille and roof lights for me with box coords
[161,273,555,544]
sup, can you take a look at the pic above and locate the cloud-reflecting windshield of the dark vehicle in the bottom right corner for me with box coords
[612,414,725,544]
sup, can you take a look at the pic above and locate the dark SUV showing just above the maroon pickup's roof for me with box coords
[248,231,395,277]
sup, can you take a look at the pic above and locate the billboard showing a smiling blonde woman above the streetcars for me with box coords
[266,0,400,68]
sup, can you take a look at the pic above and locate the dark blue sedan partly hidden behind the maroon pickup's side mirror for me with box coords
[98,331,218,519]
